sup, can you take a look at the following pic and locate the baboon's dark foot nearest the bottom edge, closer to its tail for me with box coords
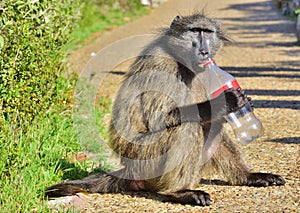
[166,190,211,206]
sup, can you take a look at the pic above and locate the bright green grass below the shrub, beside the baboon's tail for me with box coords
[0,99,111,212]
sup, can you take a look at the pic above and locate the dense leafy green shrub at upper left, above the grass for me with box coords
[0,0,80,120]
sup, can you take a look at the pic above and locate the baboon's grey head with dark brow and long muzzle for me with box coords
[167,14,227,72]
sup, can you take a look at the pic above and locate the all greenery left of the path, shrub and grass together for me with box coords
[0,0,145,212]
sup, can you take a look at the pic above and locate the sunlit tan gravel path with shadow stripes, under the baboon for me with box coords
[67,0,300,212]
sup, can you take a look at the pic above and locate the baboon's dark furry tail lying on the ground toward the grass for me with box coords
[45,170,130,197]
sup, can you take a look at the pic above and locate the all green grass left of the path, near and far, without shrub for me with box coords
[0,0,146,213]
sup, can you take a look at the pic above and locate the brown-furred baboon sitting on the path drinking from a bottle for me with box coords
[46,13,285,206]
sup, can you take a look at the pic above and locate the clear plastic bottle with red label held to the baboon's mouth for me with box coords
[204,59,263,144]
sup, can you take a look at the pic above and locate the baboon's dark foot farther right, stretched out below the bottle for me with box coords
[245,173,285,187]
